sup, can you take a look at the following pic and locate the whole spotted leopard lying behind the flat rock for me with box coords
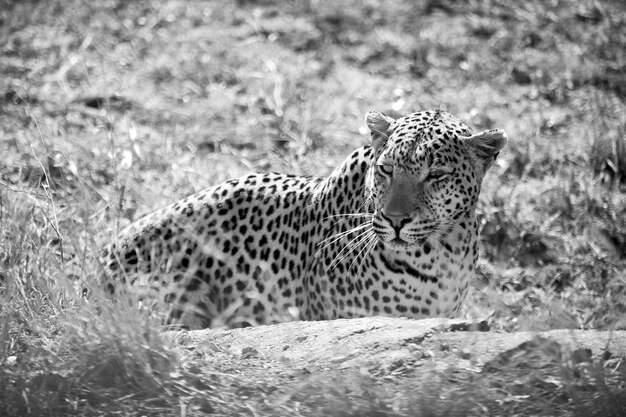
[100,110,508,329]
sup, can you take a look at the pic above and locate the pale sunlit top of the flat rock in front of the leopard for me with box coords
[170,317,626,365]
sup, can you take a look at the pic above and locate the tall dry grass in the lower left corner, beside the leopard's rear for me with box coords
[0,184,237,416]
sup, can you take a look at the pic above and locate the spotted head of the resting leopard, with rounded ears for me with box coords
[366,111,507,250]
